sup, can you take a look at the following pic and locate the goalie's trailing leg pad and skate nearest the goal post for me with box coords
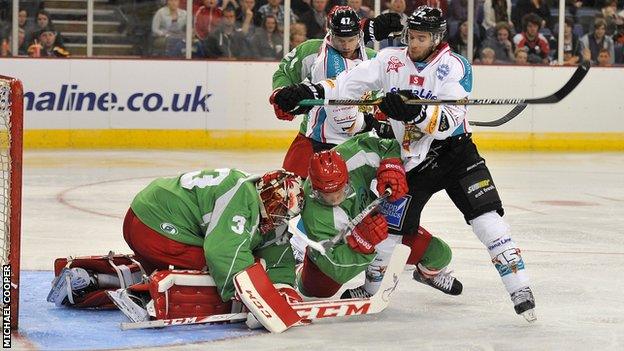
[47,251,145,308]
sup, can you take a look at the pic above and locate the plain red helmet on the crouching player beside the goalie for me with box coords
[308,150,351,206]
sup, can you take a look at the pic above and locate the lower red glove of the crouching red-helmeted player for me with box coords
[346,213,388,254]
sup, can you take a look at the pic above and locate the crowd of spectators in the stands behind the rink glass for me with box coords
[0,0,624,66]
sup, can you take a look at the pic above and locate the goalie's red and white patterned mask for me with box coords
[256,170,303,234]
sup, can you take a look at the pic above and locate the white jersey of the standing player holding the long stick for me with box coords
[321,44,472,171]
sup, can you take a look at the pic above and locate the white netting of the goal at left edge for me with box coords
[0,78,11,266]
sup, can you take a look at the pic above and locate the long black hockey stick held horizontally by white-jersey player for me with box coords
[299,62,590,106]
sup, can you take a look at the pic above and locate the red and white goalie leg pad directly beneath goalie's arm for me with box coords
[146,270,232,319]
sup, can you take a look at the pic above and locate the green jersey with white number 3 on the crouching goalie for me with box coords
[131,168,295,301]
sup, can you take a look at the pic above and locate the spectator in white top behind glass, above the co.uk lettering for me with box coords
[152,0,186,56]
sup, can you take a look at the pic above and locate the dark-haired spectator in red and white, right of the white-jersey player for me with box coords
[513,13,550,63]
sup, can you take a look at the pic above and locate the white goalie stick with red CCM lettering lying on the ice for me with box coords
[121,244,411,330]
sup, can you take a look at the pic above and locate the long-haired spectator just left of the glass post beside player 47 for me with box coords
[249,15,284,60]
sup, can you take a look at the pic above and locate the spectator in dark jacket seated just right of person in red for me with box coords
[203,9,250,59]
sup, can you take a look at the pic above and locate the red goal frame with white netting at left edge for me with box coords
[0,75,24,329]
